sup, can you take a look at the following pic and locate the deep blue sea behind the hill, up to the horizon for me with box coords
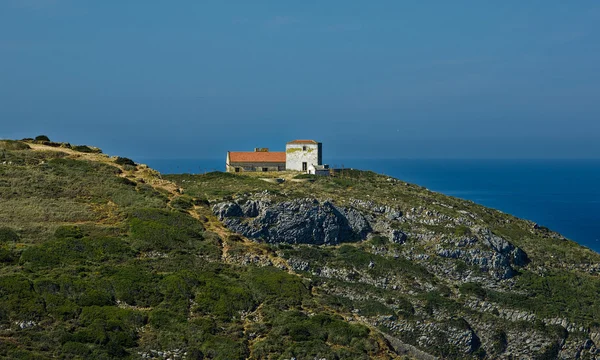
[140,159,600,252]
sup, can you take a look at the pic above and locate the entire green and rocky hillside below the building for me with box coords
[0,140,600,360]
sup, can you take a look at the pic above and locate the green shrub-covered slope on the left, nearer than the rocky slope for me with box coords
[0,142,398,359]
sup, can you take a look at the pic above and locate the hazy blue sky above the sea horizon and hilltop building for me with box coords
[0,0,600,159]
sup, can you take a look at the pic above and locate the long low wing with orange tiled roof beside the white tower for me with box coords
[225,148,285,172]
